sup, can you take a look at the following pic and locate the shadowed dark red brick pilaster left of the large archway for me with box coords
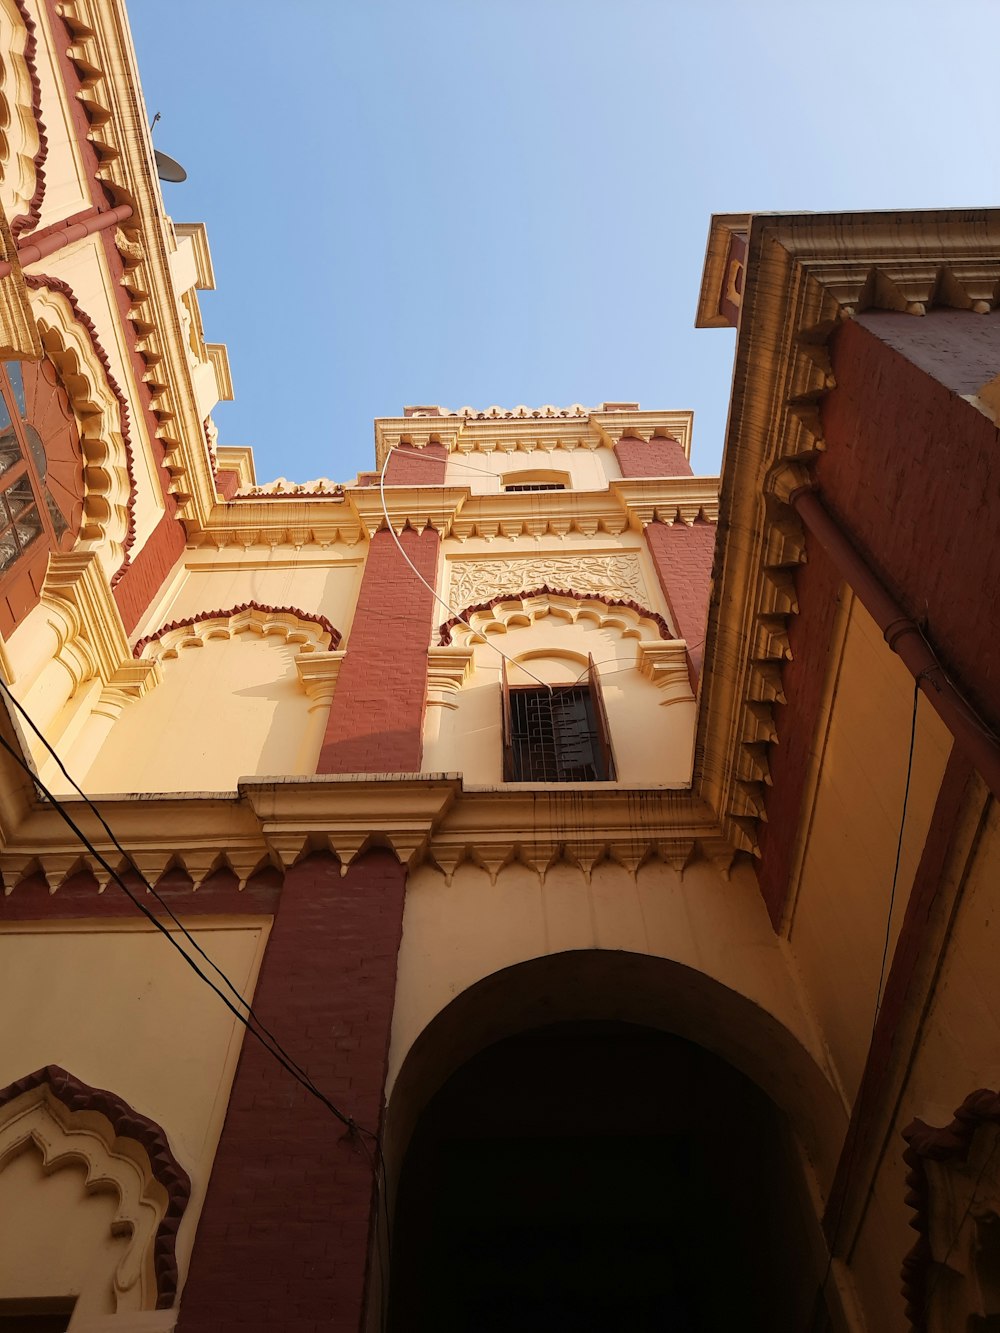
[177,850,407,1333]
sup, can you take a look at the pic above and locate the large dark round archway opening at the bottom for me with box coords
[387,950,848,1333]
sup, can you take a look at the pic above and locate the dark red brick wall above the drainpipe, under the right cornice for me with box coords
[816,312,1000,726]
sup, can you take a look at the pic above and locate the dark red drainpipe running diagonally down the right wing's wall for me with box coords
[788,487,1000,797]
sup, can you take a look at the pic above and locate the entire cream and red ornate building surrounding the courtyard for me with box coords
[0,0,1000,1333]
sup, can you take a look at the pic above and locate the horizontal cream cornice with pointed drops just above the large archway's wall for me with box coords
[0,773,735,895]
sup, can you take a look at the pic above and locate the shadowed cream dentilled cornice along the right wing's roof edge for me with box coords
[695,209,1000,852]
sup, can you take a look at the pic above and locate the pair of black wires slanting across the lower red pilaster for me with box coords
[0,681,377,1138]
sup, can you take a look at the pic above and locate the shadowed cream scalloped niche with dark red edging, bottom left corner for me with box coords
[0,1065,191,1314]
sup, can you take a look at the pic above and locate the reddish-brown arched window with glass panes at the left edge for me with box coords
[0,361,84,635]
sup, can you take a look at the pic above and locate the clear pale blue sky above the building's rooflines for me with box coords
[131,0,1000,481]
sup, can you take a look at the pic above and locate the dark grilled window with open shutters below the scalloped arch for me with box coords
[501,657,615,782]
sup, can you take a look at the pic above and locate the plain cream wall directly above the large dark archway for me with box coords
[387,861,844,1173]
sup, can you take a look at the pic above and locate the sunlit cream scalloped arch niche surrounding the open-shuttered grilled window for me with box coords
[424,588,695,786]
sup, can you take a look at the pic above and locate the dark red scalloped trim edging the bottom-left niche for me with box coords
[0,1065,191,1310]
